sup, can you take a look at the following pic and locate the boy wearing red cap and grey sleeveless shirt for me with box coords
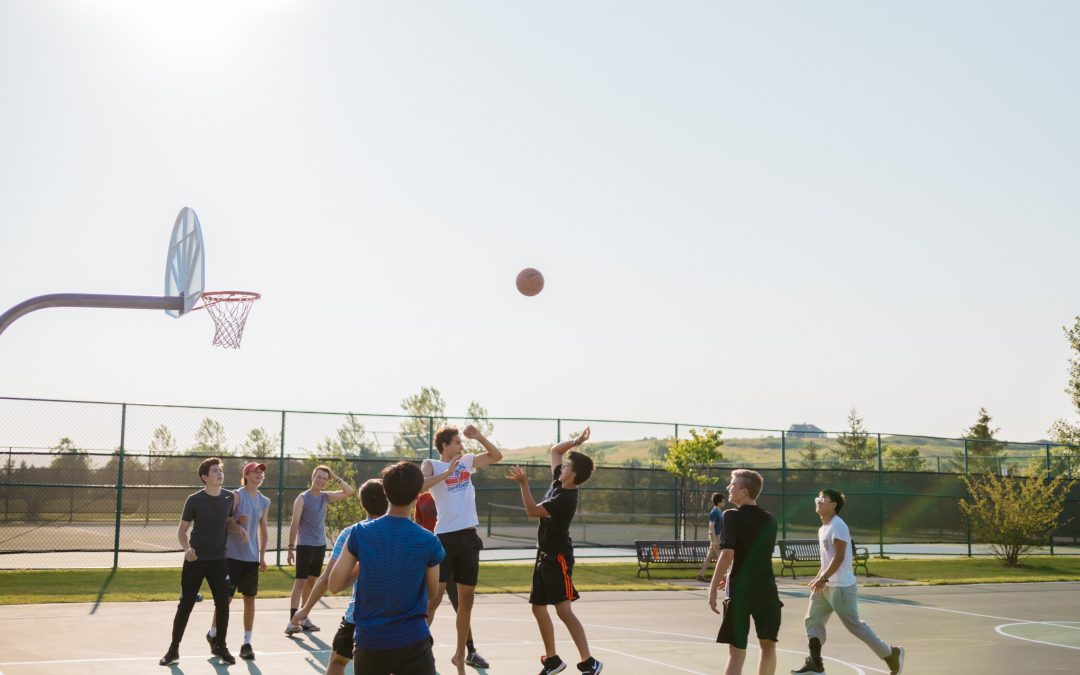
[206,462,270,661]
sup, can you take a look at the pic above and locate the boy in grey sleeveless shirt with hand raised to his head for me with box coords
[285,464,356,635]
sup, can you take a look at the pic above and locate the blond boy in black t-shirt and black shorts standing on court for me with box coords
[708,469,783,675]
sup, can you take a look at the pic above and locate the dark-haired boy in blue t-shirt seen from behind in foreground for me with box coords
[329,461,446,675]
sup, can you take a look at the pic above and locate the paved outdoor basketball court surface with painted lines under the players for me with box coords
[0,583,1080,675]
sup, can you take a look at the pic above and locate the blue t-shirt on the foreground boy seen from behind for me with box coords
[346,515,446,649]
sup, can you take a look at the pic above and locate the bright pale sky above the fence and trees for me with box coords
[0,0,1080,441]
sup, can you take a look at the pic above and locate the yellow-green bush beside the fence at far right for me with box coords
[959,471,1077,567]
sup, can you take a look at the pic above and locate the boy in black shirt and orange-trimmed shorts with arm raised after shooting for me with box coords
[507,427,604,675]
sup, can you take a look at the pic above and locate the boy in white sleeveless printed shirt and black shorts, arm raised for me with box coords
[420,424,502,675]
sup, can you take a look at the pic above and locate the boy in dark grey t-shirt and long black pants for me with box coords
[159,457,247,665]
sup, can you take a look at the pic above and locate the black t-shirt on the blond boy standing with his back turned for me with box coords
[720,504,777,597]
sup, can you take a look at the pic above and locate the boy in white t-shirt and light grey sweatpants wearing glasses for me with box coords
[792,489,904,675]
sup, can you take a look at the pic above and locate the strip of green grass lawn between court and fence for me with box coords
[0,556,1080,605]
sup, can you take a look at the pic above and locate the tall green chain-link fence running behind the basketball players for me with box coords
[0,397,1080,567]
